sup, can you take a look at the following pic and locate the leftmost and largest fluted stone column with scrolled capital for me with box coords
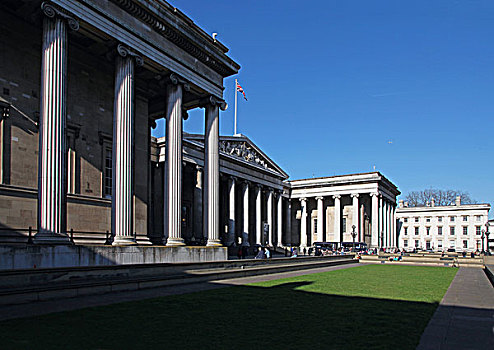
[35,3,79,244]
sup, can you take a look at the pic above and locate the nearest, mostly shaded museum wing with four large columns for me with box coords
[0,0,239,249]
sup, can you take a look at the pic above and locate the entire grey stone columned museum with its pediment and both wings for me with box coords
[0,0,400,262]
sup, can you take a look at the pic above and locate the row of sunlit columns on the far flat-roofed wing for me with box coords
[298,192,397,248]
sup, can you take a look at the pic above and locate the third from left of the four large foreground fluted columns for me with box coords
[165,73,189,246]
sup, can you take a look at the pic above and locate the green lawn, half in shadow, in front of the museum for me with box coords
[0,265,456,350]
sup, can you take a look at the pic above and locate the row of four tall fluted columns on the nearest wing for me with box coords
[35,3,226,246]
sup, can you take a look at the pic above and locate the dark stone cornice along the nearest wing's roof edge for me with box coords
[110,0,240,77]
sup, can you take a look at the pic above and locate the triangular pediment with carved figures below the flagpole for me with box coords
[184,134,288,179]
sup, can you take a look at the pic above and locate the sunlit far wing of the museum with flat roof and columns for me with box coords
[288,172,400,248]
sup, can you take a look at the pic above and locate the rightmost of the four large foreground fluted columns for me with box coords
[204,96,226,247]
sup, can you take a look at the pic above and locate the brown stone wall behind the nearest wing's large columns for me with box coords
[0,9,150,235]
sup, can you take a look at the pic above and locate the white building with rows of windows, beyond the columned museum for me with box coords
[396,197,491,251]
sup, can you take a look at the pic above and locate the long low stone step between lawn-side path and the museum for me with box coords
[0,257,355,305]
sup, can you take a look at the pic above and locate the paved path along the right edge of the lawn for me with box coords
[417,267,494,350]
